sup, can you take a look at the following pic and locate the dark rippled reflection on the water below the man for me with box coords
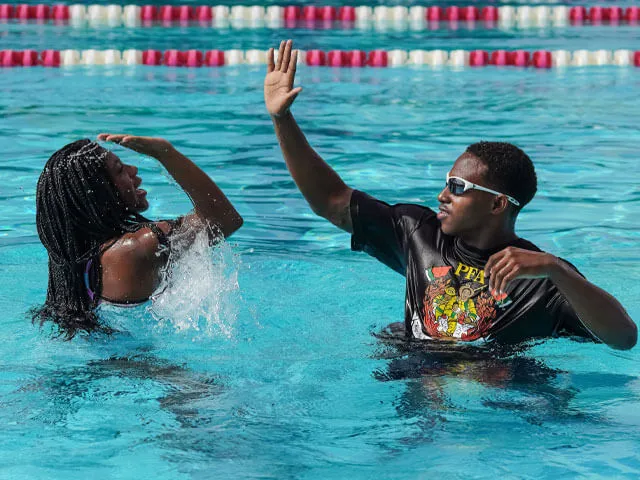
[373,328,635,443]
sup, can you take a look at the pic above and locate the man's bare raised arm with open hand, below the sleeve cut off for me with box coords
[264,40,353,233]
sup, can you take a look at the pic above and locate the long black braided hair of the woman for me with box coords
[30,139,149,340]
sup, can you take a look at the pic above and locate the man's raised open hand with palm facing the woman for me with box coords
[264,40,302,117]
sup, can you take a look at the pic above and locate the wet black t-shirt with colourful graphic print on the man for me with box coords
[351,190,595,343]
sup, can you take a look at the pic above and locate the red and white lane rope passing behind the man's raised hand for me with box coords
[0,49,640,69]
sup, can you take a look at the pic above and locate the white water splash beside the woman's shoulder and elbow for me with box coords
[148,216,240,338]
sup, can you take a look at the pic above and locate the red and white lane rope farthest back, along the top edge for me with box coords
[0,4,640,30]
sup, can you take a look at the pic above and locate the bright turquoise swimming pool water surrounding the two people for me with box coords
[0,4,640,479]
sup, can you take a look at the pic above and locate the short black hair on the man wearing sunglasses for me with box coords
[467,142,538,211]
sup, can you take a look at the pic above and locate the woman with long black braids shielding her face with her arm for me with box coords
[32,134,242,339]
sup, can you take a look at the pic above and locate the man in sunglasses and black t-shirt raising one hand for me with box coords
[264,41,637,349]
